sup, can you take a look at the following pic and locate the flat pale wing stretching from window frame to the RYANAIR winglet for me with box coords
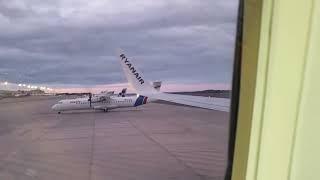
[142,93,230,112]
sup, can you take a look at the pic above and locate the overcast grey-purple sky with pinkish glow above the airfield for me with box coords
[0,0,238,90]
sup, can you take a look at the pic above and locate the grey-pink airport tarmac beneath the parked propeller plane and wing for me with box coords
[0,97,229,180]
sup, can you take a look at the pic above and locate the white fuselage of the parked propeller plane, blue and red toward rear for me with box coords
[52,96,150,112]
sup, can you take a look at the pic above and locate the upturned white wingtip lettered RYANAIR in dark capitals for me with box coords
[118,50,157,93]
